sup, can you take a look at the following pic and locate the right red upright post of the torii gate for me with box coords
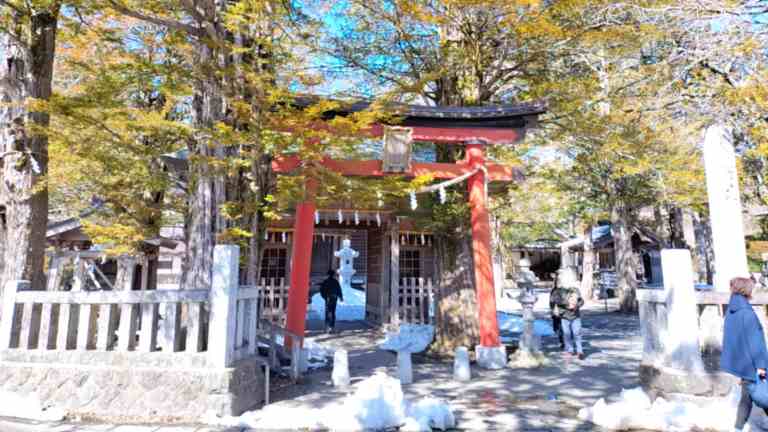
[467,144,500,347]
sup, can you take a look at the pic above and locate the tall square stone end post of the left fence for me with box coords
[208,245,240,368]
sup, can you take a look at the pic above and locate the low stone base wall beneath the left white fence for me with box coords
[0,352,265,422]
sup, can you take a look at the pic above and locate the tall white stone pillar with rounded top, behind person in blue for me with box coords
[704,125,749,292]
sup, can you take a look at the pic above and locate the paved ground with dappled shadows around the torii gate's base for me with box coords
[273,303,642,431]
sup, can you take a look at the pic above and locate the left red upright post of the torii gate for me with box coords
[286,182,317,336]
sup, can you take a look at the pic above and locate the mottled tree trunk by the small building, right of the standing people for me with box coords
[611,205,637,312]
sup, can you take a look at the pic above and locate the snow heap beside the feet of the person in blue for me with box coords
[579,386,741,432]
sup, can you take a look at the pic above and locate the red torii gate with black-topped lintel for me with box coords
[272,103,545,358]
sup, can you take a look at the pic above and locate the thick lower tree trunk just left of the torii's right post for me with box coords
[430,236,480,356]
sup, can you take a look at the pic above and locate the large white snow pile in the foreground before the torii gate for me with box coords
[203,374,456,432]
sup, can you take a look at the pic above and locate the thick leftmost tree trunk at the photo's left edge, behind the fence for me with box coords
[0,10,58,308]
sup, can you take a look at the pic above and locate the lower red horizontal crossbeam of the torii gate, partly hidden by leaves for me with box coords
[272,156,515,182]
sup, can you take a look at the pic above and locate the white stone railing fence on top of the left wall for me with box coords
[0,245,302,378]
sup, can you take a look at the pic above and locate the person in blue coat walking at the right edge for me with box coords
[720,277,768,432]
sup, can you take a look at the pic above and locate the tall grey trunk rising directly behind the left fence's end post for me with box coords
[182,36,225,289]
